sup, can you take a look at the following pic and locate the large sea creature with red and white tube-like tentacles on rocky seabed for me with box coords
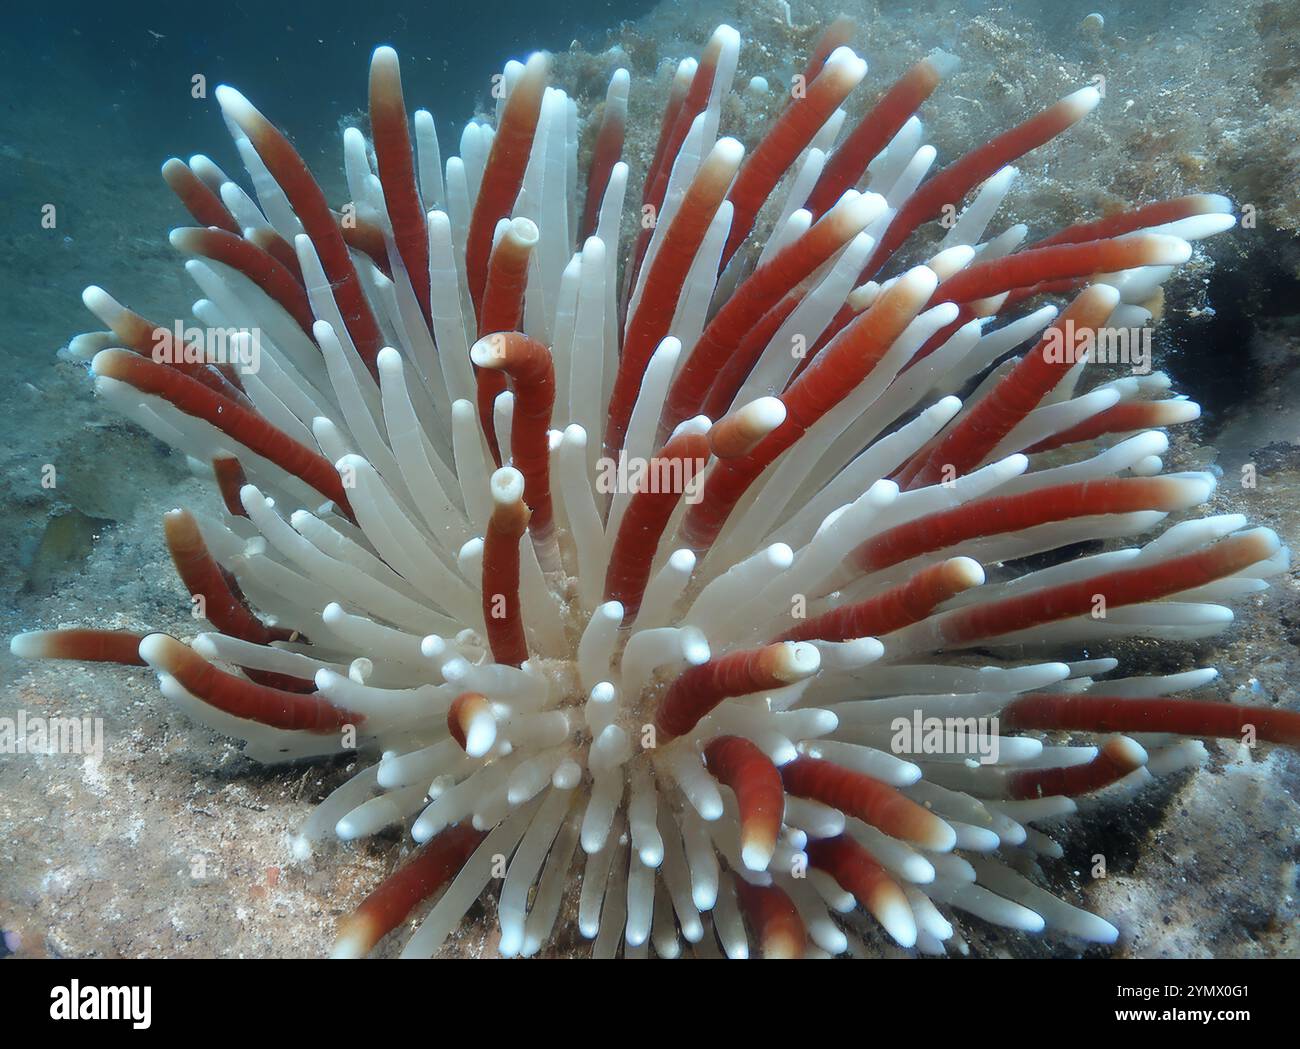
[12,21,1300,958]
